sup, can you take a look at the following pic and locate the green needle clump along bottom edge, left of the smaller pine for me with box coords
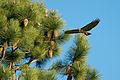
[19,68,57,80]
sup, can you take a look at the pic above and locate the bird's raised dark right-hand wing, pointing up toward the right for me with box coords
[81,19,100,31]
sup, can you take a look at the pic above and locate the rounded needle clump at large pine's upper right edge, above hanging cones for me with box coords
[42,10,64,31]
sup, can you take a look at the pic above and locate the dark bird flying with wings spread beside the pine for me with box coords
[65,19,100,36]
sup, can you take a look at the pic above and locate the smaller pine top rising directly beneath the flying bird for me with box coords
[51,34,100,80]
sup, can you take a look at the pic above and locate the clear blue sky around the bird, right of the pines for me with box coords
[42,0,120,80]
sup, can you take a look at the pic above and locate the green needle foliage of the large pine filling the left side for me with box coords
[0,0,68,80]
